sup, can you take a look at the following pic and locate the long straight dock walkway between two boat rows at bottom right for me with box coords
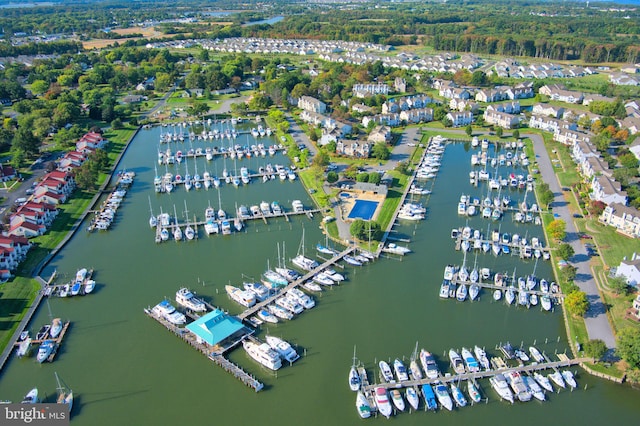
[362,354,593,393]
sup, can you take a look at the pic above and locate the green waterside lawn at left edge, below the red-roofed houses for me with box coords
[0,277,40,349]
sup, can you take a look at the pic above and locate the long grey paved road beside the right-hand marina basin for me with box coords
[523,134,616,348]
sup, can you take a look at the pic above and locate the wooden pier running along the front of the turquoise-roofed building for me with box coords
[144,309,264,392]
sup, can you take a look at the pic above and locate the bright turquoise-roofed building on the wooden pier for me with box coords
[186,309,248,346]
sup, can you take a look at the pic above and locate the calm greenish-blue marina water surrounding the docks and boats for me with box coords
[0,129,640,425]
